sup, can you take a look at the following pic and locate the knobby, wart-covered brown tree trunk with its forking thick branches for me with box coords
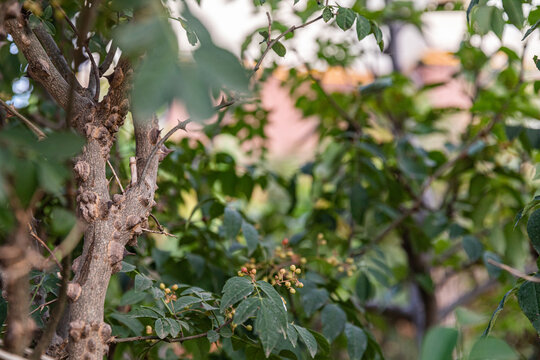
[4,4,166,360]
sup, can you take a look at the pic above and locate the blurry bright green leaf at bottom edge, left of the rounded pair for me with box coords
[420,327,458,360]
